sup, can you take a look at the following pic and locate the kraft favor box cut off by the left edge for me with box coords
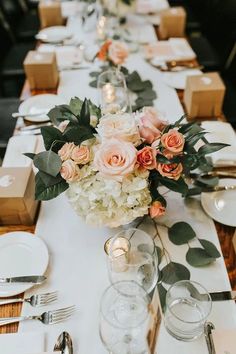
[0,167,38,225]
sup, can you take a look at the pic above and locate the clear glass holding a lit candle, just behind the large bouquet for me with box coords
[97,69,131,114]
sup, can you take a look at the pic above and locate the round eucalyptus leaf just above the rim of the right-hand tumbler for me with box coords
[162,262,190,284]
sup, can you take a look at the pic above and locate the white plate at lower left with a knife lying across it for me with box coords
[0,231,49,297]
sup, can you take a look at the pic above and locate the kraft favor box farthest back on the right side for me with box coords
[158,6,186,39]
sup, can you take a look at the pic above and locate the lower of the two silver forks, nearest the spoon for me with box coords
[0,305,76,326]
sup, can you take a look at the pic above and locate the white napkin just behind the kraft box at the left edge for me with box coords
[2,135,38,167]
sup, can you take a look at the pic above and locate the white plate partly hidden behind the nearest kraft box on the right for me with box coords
[162,69,202,90]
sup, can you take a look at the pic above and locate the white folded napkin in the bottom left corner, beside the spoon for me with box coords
[0,332,45,354]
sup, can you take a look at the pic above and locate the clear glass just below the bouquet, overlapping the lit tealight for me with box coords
[105,228,158,293]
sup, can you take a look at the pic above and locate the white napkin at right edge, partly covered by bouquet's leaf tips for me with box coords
[202,121,236,167]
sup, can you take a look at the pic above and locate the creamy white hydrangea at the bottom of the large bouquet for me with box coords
[67,165,151,227]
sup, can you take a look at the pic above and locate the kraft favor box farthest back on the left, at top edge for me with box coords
[38,0,64,28]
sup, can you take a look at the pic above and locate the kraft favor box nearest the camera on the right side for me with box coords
[184,73,225,119]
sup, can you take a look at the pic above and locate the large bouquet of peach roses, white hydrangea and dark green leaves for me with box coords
[26,98,225,227]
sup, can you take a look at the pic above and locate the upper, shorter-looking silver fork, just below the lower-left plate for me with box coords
[0,291,57,307]
